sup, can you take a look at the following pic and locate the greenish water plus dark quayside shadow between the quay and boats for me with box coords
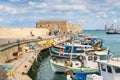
[28,50,66,80]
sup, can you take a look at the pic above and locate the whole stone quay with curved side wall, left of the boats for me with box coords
[0,36,70,80]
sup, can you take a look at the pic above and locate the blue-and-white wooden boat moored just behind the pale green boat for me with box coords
[50,44,93,58]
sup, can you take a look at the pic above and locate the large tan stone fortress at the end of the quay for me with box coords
[36,20,82,33]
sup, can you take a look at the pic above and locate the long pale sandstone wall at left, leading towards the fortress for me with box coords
[0,28,49,39]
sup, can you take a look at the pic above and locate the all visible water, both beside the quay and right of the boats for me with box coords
[33,30,120,80]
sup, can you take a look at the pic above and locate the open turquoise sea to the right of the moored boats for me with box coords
[83,30,120,57]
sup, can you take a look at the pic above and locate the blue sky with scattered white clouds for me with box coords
[0,0,120,30]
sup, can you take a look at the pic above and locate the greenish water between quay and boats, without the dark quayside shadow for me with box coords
[35,50,65,80]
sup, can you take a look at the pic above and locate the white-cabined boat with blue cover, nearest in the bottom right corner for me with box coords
[74,52,120,80]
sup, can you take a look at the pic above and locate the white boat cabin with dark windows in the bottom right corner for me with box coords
[98,59,120,80]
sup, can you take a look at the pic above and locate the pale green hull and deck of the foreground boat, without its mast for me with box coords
[50,56,98,73]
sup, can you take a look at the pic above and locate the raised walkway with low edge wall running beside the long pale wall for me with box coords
[0,34,70,53]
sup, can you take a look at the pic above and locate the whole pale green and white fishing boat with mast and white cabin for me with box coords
[50,46,107,73]
